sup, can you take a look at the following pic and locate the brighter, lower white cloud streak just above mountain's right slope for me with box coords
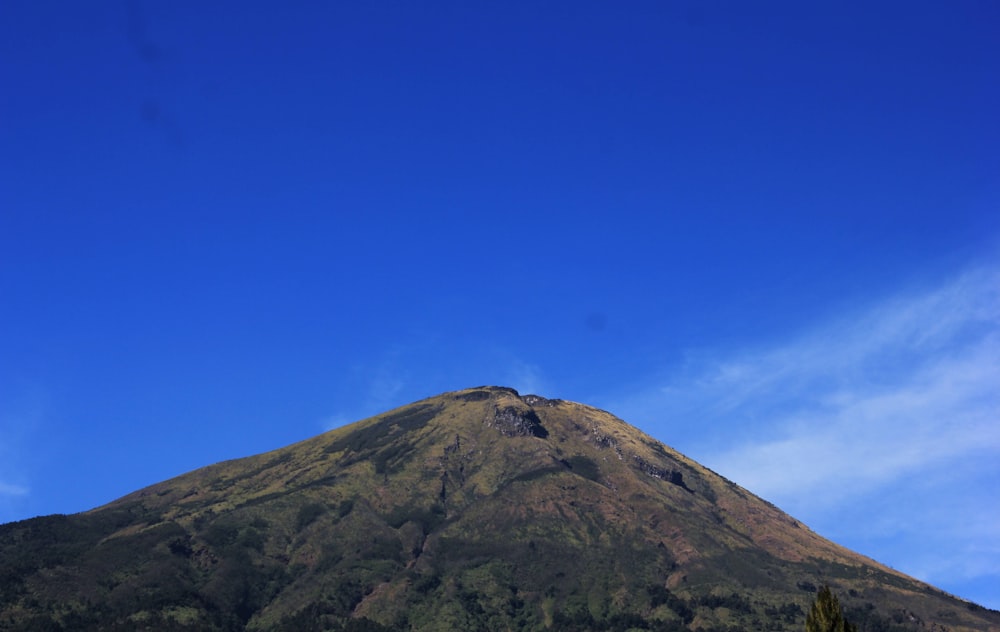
[709,336,1000,504]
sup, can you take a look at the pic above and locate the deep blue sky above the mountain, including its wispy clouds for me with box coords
[0,0,1000,608]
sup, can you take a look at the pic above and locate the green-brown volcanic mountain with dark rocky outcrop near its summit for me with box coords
[0,387,1000,632]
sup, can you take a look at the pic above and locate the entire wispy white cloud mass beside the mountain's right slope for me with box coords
[612,265,1000,607]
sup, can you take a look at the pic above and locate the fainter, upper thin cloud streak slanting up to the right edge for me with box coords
[664,268,1000,428]
